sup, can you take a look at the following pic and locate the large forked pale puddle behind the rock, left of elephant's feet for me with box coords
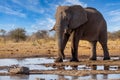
[0,58,54,72]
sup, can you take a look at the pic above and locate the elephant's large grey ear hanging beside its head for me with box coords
[69,5,88,29]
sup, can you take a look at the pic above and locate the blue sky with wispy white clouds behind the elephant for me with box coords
[0,0,120,34]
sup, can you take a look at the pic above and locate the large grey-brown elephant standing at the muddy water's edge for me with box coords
[52,5,110,62]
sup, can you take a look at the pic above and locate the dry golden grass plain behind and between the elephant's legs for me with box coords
[0,39,120,58]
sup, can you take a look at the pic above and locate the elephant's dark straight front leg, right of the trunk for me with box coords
[70,32,79,62]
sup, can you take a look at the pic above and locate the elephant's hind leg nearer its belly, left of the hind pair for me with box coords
[90,41,97,60]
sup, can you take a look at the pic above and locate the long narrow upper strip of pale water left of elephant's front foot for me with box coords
[0,58,54,66]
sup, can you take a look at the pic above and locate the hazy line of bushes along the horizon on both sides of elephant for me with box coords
[0,28,120,42]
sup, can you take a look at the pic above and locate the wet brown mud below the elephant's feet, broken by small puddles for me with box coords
[0,59,120,76]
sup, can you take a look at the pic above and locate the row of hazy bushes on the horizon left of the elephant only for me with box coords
[0,28,52,42]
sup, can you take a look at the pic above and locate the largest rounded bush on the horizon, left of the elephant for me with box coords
[9,28,27,42]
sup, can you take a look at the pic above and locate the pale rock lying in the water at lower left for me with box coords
[8,67,29,74]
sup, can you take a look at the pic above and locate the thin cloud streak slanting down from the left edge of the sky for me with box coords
[0,6,26,17]
